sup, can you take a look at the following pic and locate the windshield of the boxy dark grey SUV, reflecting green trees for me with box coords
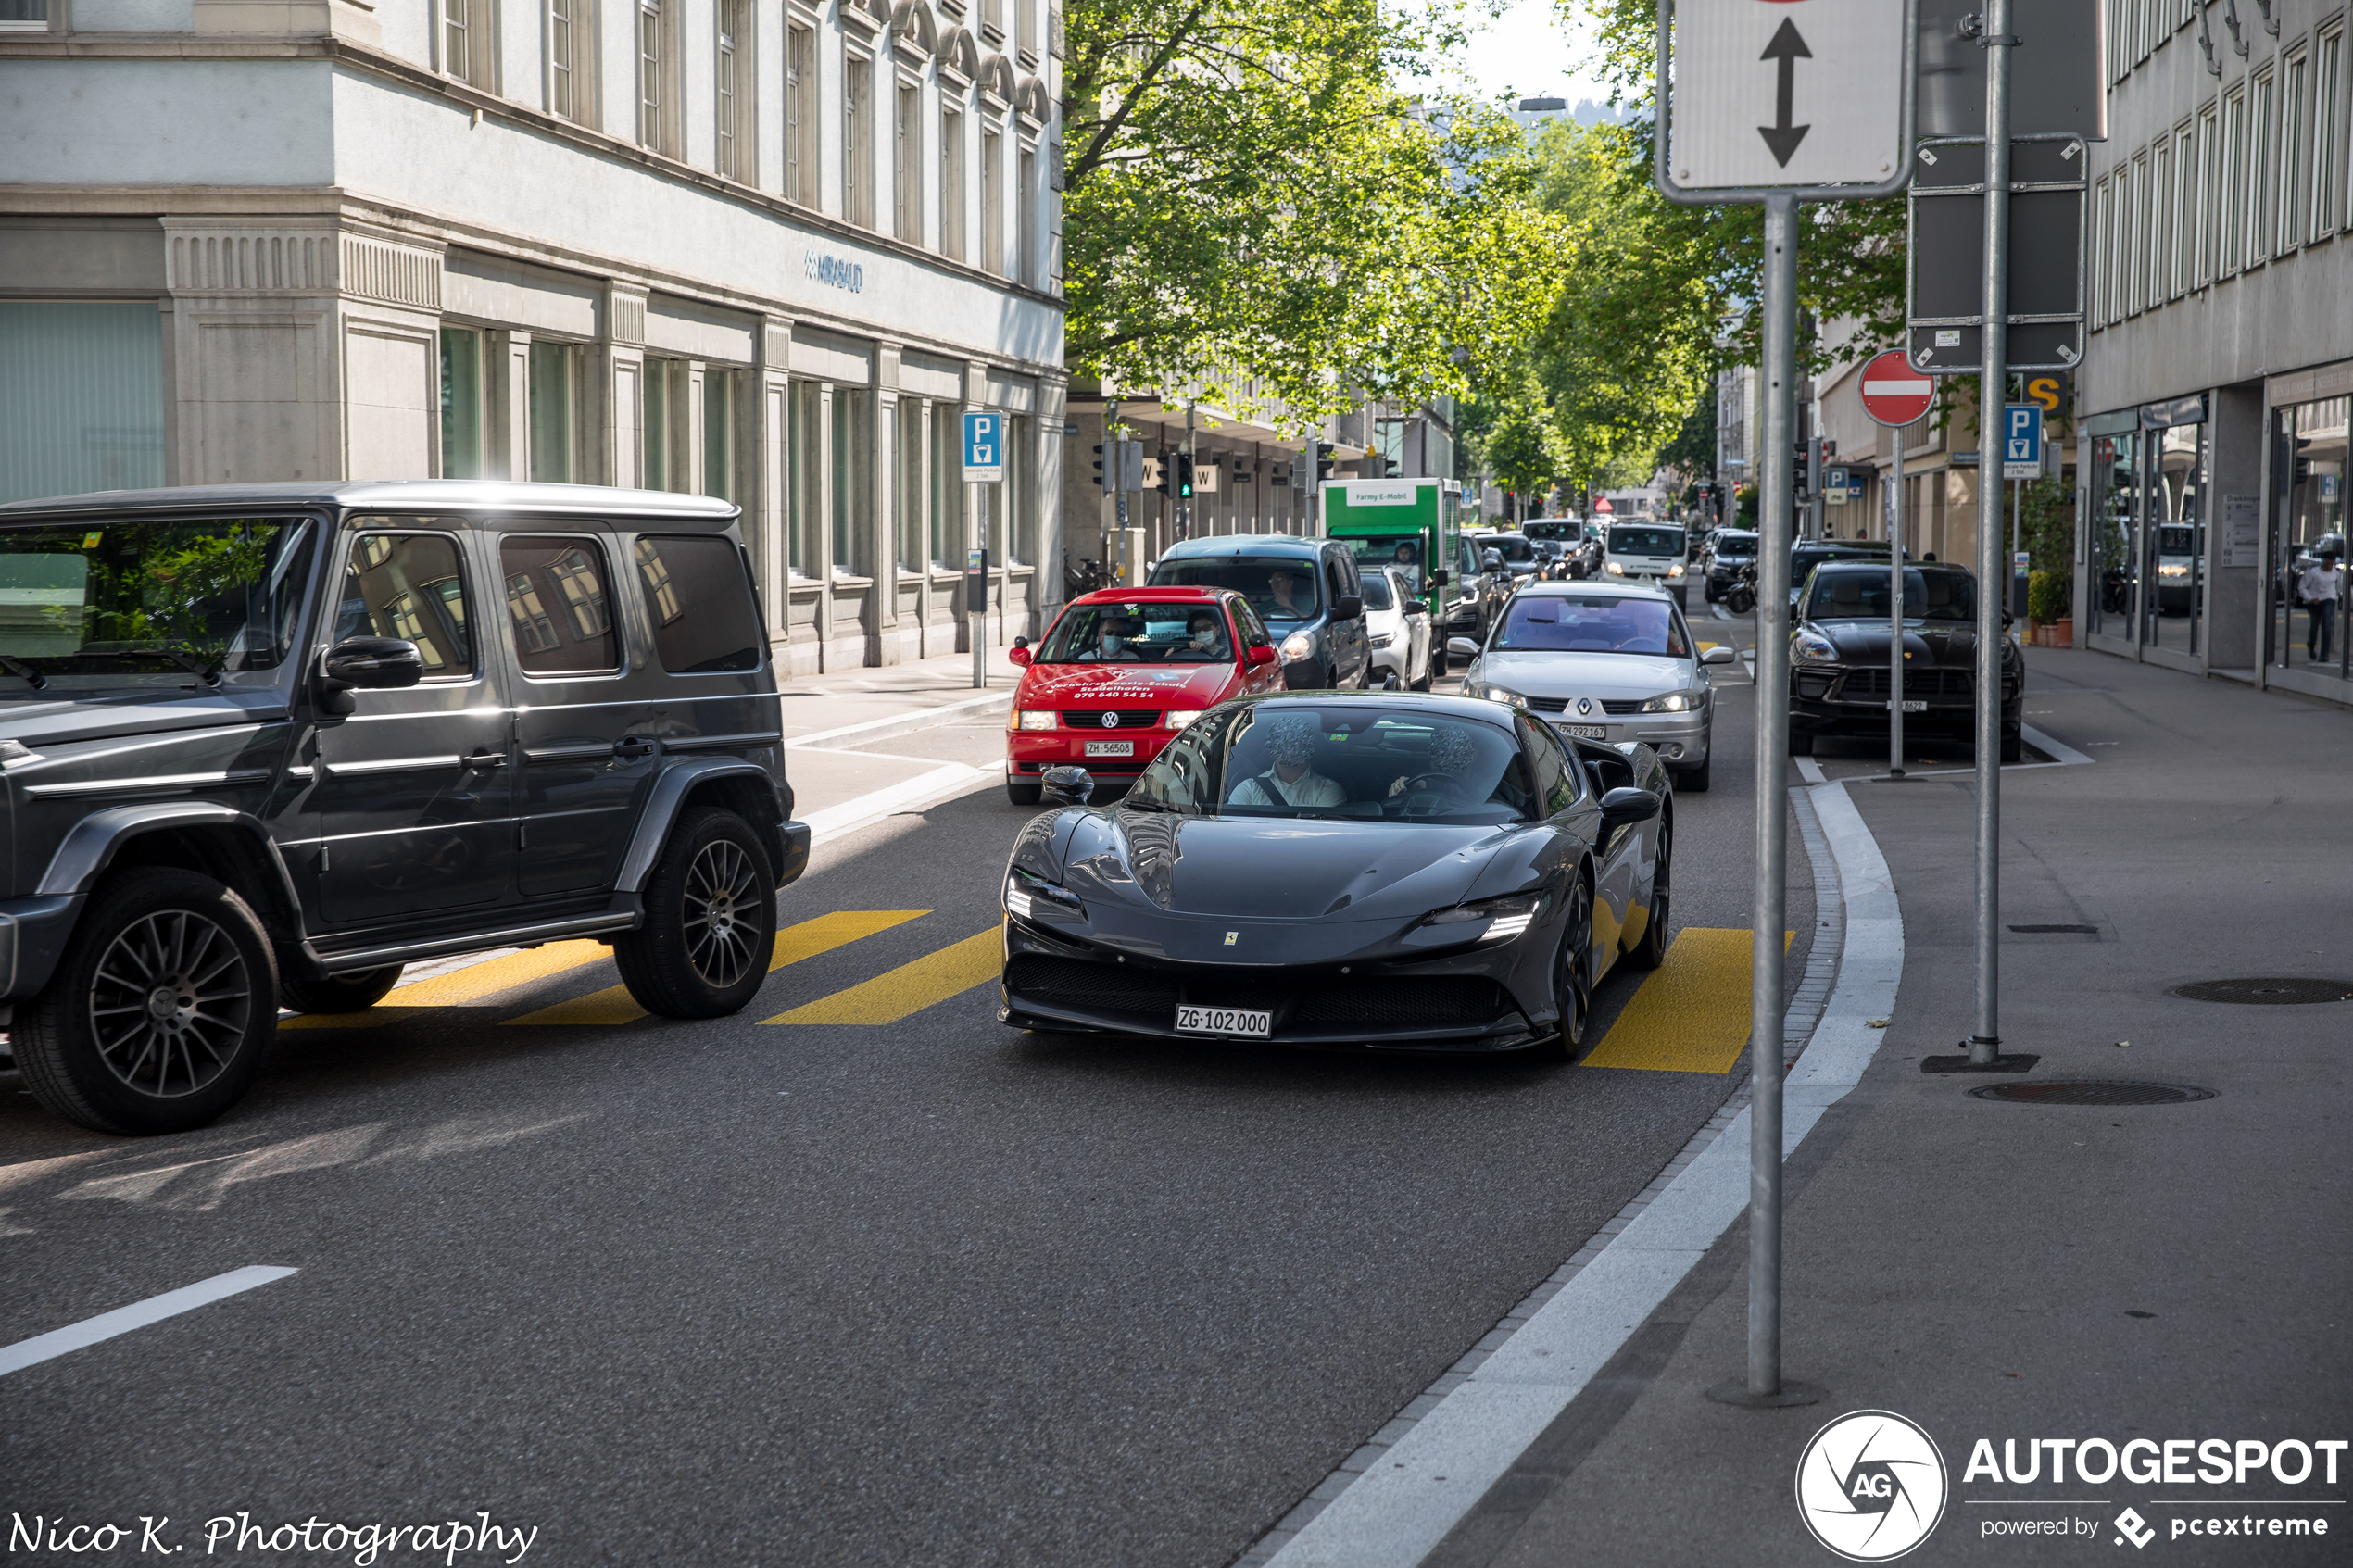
[0,517,310,691]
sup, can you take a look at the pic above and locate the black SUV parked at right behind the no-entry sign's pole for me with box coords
[1788,558,2026,761]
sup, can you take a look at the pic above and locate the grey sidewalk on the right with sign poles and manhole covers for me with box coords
[1308,649,2353,1568]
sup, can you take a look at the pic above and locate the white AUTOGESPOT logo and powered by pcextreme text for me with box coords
[1798,1411,2353,1563]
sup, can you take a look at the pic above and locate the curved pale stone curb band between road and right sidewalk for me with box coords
[1268,783,1904,1568]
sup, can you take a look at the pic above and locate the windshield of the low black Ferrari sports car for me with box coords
[1123,703,1532,825]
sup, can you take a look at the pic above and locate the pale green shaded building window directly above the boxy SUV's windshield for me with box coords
[0,303,163,501]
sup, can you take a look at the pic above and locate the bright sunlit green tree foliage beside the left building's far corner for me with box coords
[1063,0,1560,423]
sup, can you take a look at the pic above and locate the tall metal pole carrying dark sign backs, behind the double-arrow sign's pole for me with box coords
[1969,0,2014,1070]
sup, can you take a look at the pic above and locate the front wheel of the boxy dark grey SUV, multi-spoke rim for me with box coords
[12,868,278,1133]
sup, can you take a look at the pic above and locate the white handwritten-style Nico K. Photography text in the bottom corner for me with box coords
[7,1512,539,1568]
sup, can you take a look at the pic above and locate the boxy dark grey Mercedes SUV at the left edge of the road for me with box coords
[0,482,810,1133]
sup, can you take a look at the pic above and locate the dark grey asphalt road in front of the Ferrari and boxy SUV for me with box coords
[0,644,1814,1568]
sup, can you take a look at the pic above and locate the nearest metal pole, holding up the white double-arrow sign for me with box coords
[1748,191,1798,1399]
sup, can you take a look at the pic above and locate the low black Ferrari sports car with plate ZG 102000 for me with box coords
[998,691,1673,1056]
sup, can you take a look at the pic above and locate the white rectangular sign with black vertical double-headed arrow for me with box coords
[1668,0,1906,193]
